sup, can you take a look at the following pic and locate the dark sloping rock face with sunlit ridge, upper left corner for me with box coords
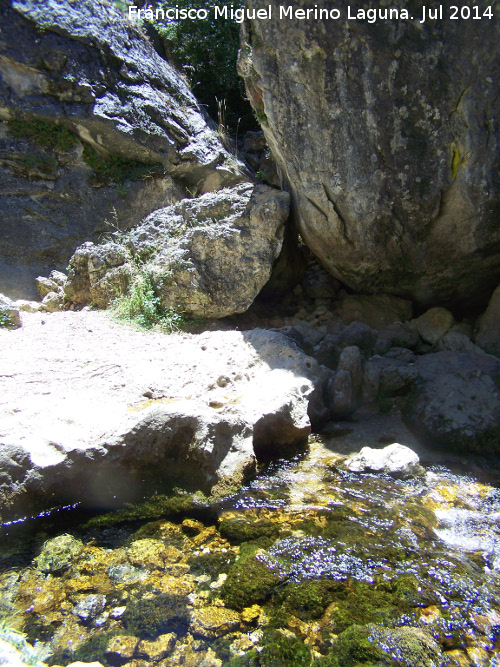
[0,0,242,298]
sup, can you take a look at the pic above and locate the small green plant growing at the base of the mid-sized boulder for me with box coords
[111,269,184,333]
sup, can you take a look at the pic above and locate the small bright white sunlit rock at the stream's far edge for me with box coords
[343,442,422,479]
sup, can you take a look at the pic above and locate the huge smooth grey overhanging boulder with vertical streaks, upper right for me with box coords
[239,0,500,305]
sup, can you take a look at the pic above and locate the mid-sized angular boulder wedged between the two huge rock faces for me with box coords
[64,183,289,317]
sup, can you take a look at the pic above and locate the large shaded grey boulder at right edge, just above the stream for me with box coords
[403,352,500,452]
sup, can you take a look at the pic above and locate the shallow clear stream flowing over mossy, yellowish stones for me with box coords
[0,420,500,667]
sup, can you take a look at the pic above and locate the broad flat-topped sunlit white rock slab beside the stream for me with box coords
[0,311,322,519]
